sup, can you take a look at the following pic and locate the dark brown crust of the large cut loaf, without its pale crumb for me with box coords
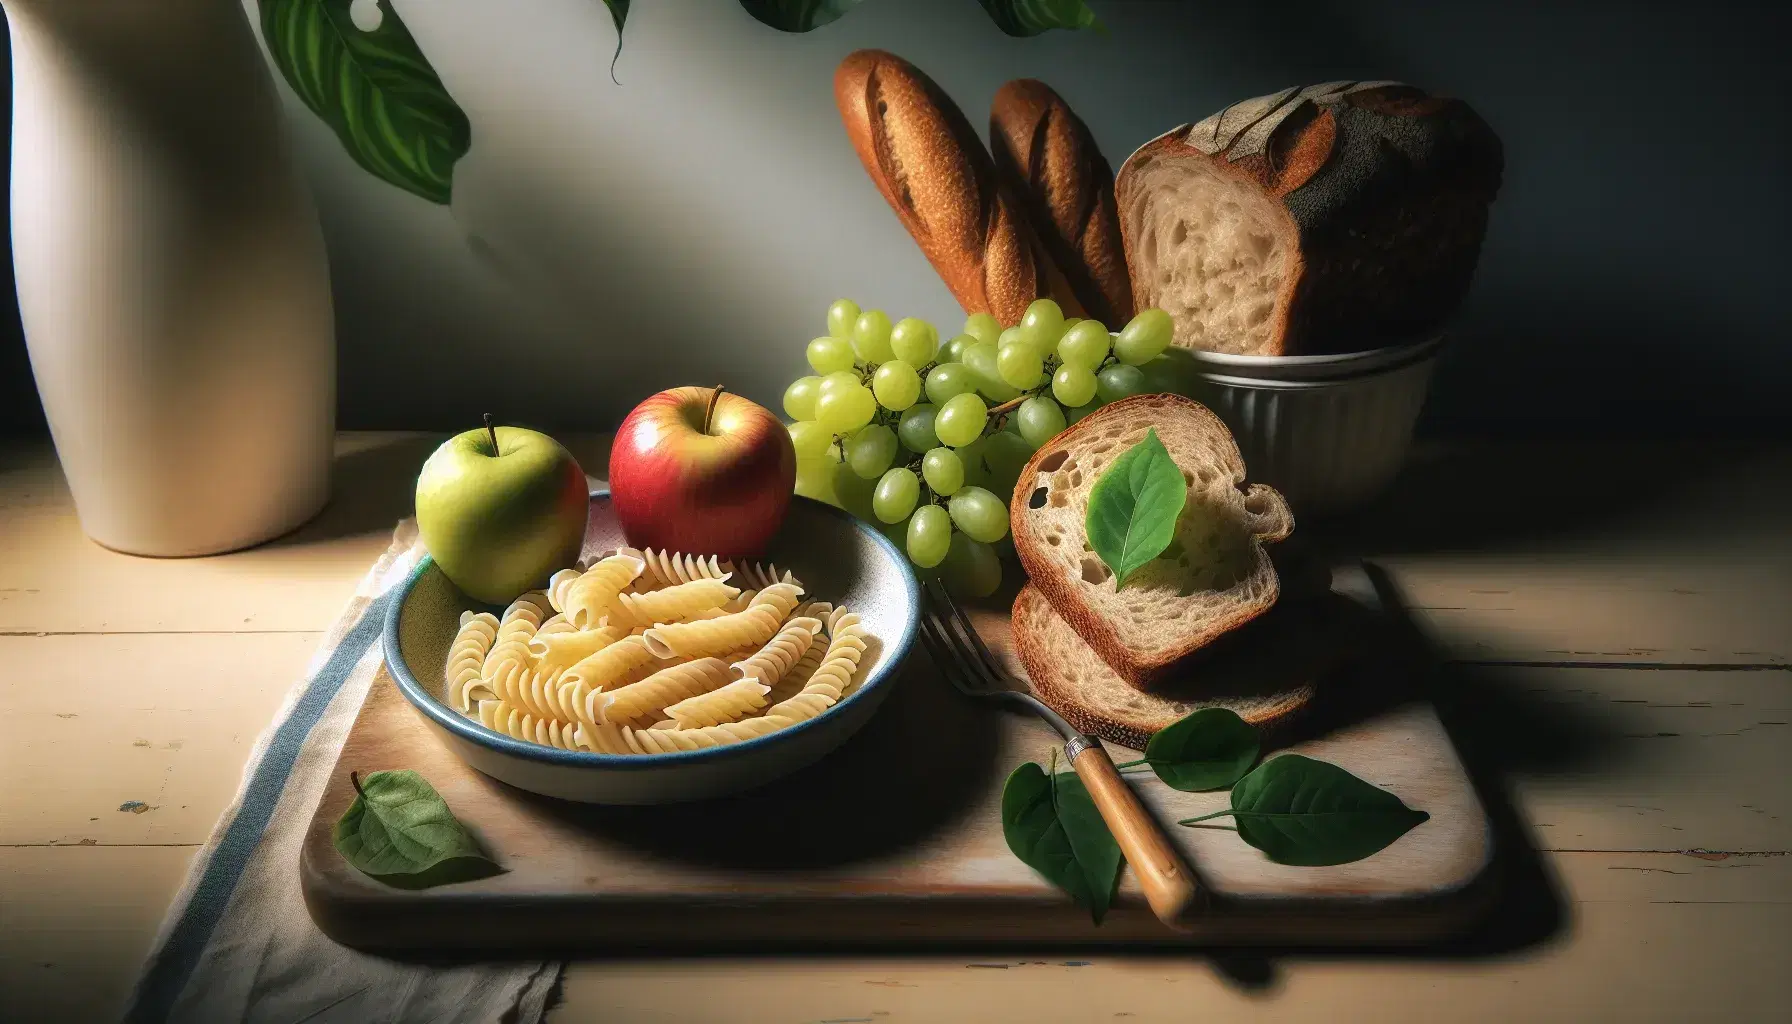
[1116,82,1503,355]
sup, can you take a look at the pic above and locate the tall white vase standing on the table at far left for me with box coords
[0,0,335,556]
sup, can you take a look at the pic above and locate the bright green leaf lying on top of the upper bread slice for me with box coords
[1084,429,1188,588]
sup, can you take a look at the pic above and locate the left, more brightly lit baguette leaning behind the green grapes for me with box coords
[833,50,1073,325]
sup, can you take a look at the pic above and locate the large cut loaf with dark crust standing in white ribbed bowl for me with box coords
[1115,82,1503,355]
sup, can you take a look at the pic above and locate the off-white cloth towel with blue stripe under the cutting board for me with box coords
[125,520,561,1024]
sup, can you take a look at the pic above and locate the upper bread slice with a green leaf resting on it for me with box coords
[1009,395,1294,690]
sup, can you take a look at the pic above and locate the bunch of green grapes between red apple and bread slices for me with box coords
[783,299,1170,597]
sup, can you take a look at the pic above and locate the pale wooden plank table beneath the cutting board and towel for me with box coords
[0,434,1792,1024]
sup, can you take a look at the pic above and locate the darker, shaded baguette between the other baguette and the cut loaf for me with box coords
[989,79,1133,330]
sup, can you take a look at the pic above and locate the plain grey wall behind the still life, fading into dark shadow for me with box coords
[0,0,1792,436]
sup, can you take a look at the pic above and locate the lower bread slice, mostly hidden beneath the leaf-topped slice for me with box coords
[1012,585,1317,750]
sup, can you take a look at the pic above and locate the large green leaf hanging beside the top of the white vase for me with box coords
[258,0,471,203]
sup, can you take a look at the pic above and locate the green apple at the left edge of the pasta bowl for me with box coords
[418,416,590,604]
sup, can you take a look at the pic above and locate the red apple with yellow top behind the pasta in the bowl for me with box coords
[609,387,796,560]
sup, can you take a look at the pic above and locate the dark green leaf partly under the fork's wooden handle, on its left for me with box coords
[1002,760,1120,924]
